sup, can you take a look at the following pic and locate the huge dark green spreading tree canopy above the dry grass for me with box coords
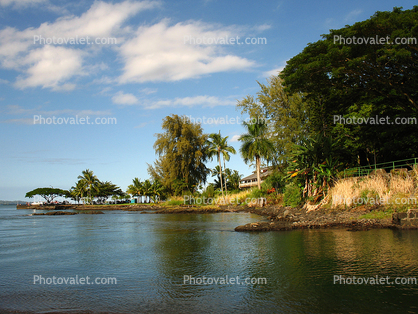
[280,6,418,164]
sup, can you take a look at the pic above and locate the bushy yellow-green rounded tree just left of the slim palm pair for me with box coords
[148,115,209,194]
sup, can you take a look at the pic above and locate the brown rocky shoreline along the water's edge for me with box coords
[17,204,418,232]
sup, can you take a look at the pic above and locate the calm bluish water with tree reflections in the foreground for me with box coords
[0,206,418,313]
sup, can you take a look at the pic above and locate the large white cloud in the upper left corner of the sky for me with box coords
[0,0,159,90]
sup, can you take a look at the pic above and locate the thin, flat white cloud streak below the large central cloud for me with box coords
[142,95,236,109]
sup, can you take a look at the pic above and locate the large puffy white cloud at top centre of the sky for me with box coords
[120,20,254,83]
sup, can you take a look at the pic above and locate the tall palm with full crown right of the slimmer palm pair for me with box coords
[239,118,274,189]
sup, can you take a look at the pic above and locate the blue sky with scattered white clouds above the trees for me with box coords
[0,0,416,201]
